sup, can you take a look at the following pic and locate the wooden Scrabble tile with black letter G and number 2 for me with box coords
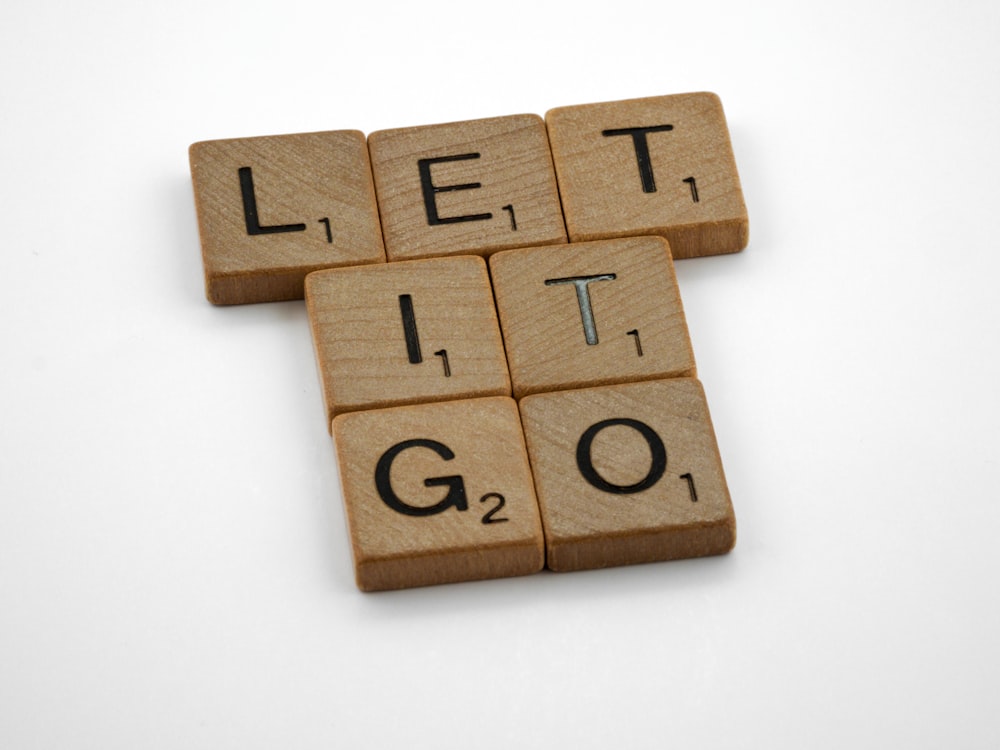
[333,398,545,591]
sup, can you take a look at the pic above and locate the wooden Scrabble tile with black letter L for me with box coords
[189,130,385,305]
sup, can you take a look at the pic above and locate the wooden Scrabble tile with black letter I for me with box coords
[306,256,511,425]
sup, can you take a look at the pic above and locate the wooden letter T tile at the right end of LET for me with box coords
[545,93,749,258]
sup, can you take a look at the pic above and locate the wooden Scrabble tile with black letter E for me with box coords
[368,115,566,260]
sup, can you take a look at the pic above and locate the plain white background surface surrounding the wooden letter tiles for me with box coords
[0,0,1000,750]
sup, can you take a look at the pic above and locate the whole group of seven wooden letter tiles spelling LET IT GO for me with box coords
[190,94,748,591]
